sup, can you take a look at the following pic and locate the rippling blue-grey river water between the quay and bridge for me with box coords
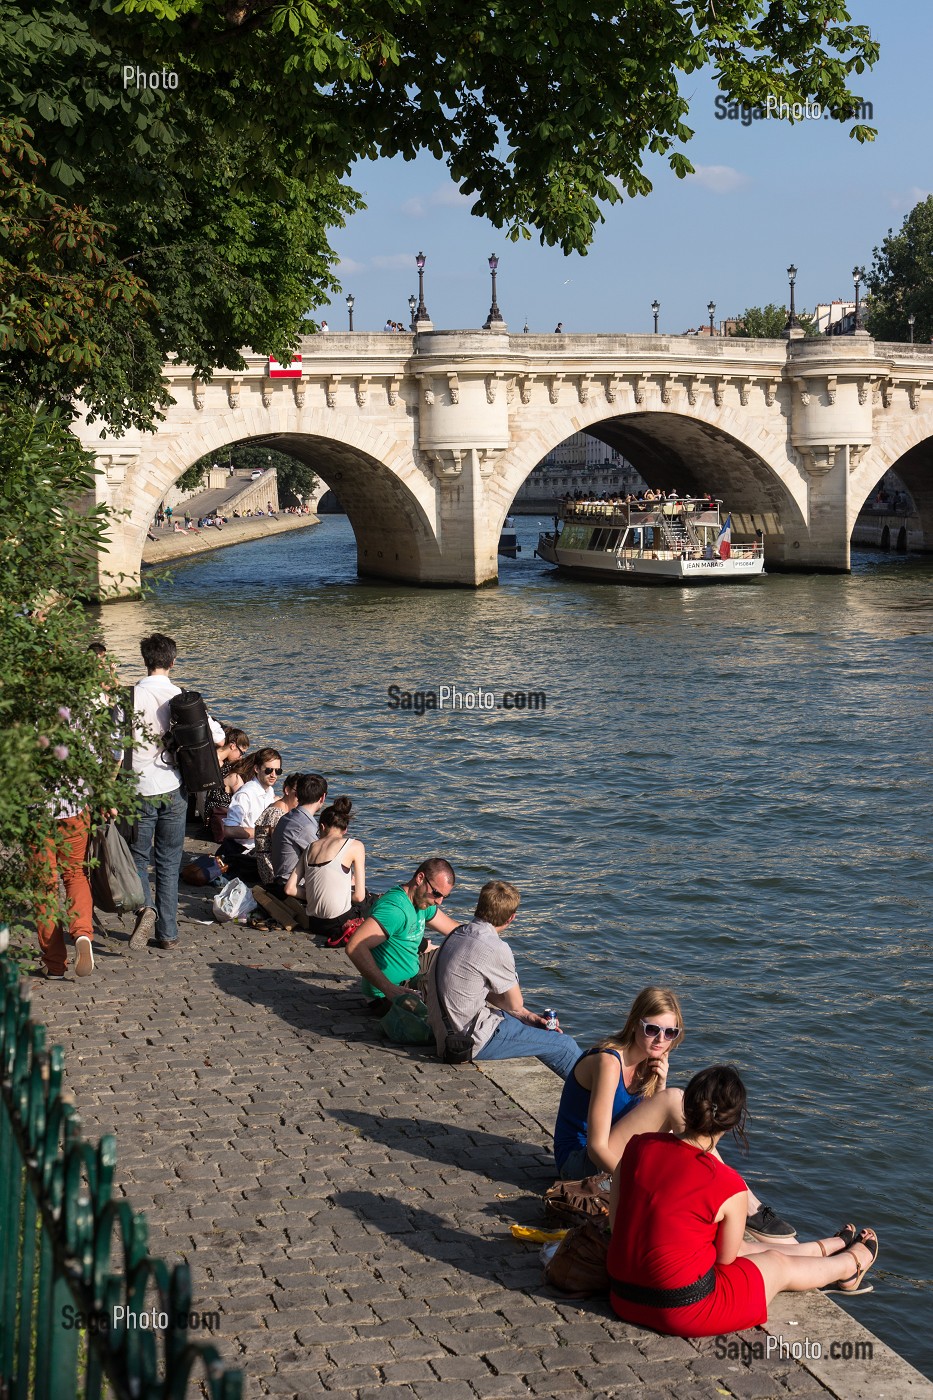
[102,517,933,1375]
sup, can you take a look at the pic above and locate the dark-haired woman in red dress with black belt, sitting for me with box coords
[607,1065,878,1337]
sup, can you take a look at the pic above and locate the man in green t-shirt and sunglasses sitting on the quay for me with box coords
[346,855,458,1015]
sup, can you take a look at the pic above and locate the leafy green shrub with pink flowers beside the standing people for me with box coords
[0,405,134,952]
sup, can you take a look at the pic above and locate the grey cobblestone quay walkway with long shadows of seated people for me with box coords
[25,845,933,1400]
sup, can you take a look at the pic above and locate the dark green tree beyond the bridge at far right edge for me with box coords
[866,195,933,343]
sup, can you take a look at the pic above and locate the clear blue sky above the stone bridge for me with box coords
[318,0,933,339]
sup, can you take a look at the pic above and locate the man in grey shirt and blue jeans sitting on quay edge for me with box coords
[427,879,580,1079]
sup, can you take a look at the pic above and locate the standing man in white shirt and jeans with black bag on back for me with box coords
[129,631,224,952]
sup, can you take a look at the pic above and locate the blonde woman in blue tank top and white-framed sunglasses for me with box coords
[553,987,684,1180]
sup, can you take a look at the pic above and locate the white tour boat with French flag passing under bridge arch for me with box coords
[535,496,765,584]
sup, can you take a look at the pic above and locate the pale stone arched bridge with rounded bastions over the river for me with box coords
[78,329,933,592]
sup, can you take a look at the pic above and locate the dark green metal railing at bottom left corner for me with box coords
[0,956,242,1400]
